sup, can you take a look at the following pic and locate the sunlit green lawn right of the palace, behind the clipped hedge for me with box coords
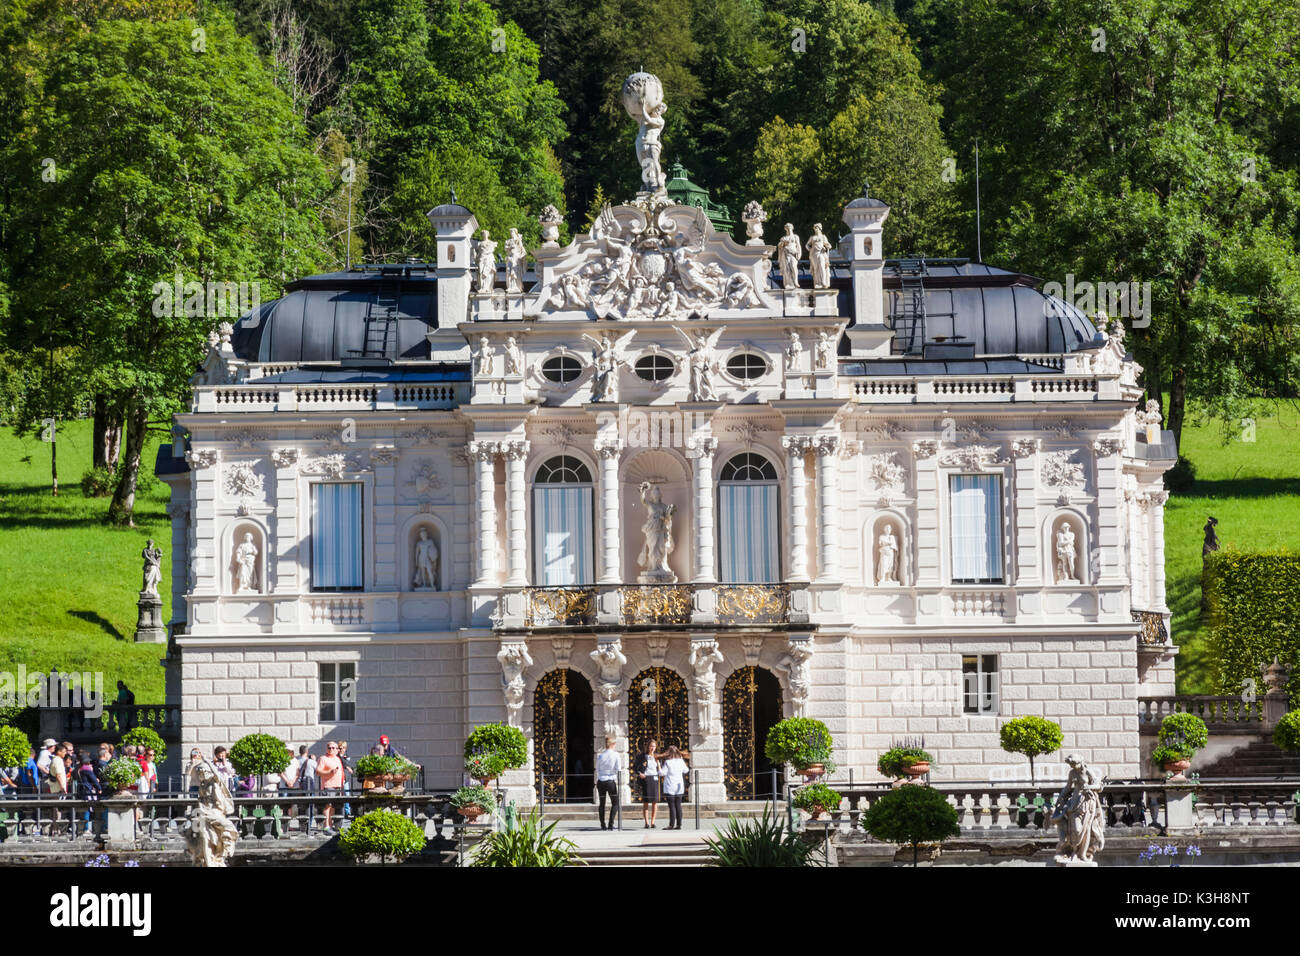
[1165,402,1300,693]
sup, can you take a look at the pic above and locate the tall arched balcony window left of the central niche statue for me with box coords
[533,455,594,587]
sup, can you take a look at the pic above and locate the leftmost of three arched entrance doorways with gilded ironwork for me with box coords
[533,670,595,804]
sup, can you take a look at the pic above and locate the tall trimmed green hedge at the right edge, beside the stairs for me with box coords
[1204,550,1300,700]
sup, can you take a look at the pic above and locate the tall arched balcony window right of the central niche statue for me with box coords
[718,451,781,584]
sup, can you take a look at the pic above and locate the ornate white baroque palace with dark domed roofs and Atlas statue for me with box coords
[159,78,1175,803]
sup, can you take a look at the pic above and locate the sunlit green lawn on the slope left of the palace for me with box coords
[0,420,173,704]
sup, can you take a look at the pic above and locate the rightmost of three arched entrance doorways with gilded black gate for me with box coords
[723,667,783,800]
